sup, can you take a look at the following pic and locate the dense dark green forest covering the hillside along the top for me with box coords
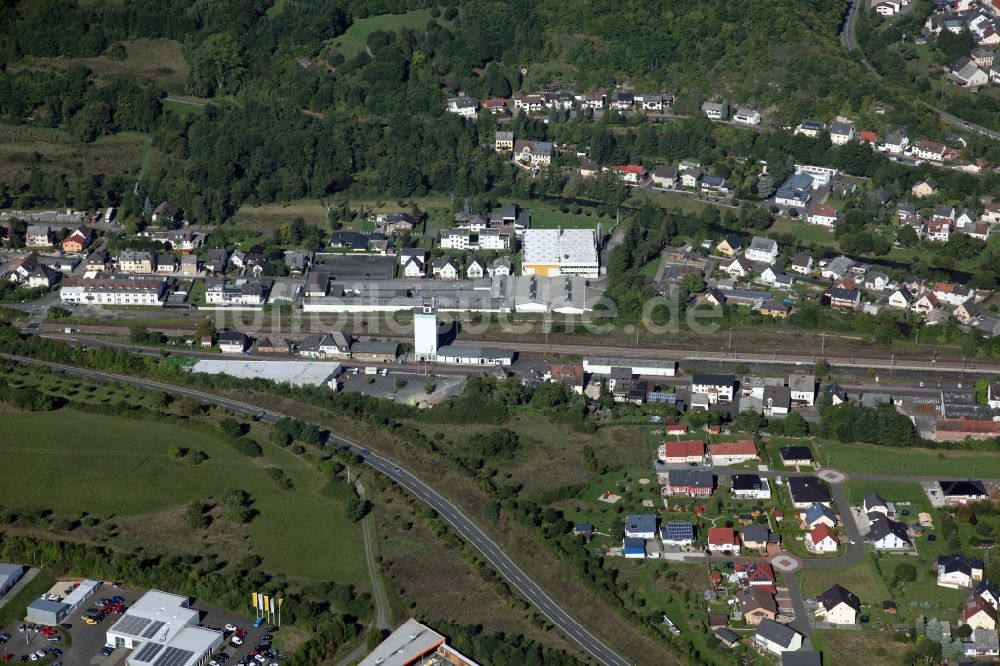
[0,0,908,221]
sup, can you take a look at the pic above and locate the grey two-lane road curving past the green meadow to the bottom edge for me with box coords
[0,354,629,666]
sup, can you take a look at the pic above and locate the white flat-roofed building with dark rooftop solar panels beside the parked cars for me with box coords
[107,590,225,666]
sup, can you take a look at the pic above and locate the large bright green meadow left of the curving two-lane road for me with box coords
[0,409,367,586]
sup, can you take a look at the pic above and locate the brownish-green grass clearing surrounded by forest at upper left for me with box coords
[23,39,188,91]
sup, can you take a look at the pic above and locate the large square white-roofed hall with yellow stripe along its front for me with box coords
[521,229,600,278]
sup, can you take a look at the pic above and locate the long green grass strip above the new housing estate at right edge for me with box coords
[815,440,1000,479]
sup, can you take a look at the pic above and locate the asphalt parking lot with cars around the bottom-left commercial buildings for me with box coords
[0,583,280,666]
